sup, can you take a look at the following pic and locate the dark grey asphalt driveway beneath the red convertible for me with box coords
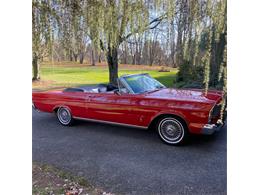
[32,110,227,195]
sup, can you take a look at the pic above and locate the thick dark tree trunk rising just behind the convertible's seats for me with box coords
[107,47,118,85]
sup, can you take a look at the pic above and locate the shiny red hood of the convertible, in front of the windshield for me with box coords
[145,88,222,103]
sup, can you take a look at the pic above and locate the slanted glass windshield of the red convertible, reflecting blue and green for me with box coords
[123,74,165,93]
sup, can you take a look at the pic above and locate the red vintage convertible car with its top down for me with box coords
[32,74,223,145]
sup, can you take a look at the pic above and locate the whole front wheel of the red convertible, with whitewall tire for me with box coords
[157,117,188,145]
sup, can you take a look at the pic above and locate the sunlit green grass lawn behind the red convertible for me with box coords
[33,65,178,88]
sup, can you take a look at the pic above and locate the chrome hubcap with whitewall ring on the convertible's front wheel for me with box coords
[159,119,184,142]
